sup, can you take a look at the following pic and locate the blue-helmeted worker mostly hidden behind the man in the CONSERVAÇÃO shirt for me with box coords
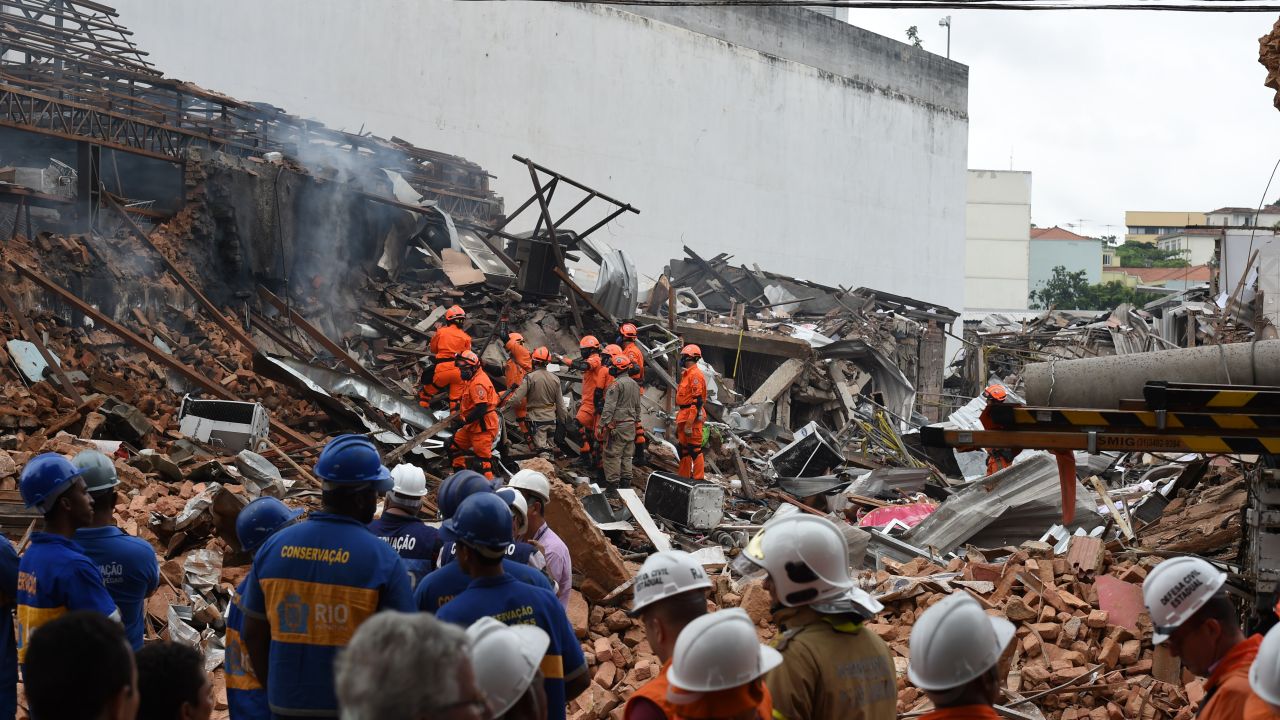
[223,497,302,720]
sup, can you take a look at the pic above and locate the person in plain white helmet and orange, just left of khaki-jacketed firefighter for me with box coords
[667,607,782,720]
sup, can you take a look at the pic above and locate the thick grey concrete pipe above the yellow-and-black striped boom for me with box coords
[1023,340,1280,409]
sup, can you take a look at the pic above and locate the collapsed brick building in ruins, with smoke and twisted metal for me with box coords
[0,0,1276,720]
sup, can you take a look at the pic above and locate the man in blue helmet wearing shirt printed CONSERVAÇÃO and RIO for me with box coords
[241,434,413,717]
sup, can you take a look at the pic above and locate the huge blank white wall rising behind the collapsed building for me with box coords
[115,0,968,309]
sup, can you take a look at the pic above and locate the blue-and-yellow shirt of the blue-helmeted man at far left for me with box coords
[18,533,118,662]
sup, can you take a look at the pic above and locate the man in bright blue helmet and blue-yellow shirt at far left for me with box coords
[17,452,120,664]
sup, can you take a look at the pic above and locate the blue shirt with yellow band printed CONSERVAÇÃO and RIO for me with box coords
[241,512,413,717]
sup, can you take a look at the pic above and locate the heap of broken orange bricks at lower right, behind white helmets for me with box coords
[868,537,1203,720]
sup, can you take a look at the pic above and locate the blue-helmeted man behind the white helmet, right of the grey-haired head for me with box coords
[435,493,591,720]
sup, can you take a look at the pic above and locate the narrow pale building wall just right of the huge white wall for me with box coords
[964,170,1032,310]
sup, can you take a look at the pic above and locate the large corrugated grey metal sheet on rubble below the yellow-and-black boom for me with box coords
[902,452,1102,552]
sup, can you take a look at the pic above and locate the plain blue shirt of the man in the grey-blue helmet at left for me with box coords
[76,525,160,650]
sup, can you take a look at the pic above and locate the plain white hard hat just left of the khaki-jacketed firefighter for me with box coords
[667,607,782,705]
